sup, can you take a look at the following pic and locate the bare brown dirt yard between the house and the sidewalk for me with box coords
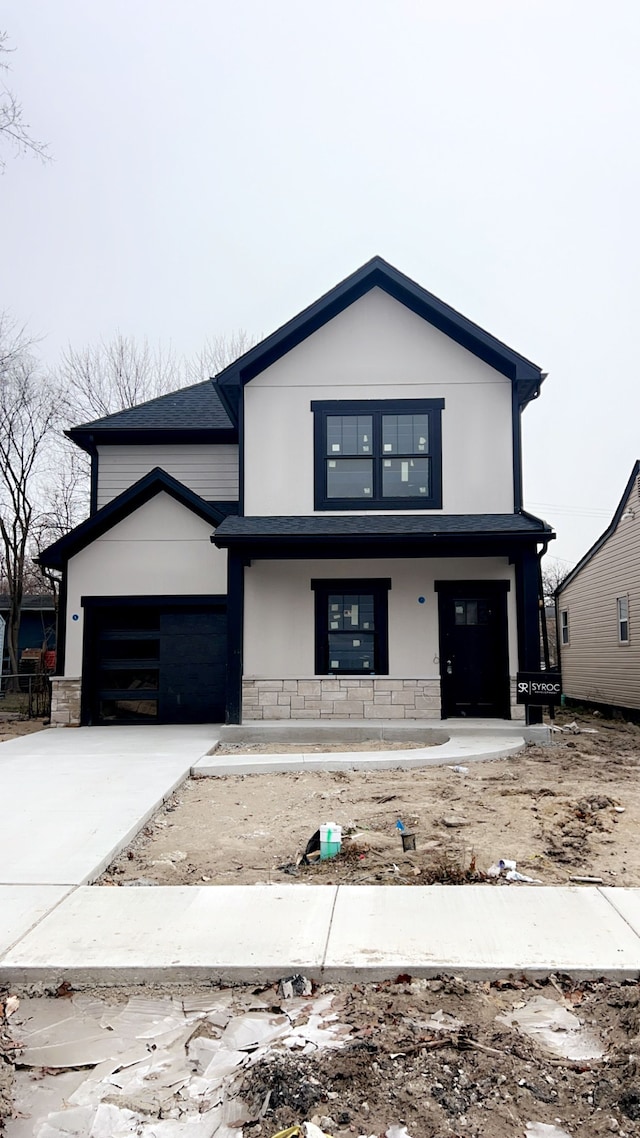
[101,714,640,885]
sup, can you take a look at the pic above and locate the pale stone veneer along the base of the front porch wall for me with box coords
[243,676,524,721]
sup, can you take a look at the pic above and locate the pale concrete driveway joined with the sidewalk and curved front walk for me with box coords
[0,725,640,988]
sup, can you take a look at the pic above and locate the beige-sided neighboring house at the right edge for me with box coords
[556,461,640,710]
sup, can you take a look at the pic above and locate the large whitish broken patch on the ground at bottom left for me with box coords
[6,989,352,1138]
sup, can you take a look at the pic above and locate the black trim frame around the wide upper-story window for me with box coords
[311,399,444,512]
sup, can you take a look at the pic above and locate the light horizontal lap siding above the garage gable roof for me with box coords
[98,443,238,509]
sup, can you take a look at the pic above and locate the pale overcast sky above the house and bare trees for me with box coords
[0,0,640,563]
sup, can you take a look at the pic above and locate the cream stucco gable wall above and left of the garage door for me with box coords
[65,493,227,676]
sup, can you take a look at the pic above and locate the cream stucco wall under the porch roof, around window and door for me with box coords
[244,558,517,679]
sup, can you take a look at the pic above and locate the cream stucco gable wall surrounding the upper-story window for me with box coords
[244,289,514,514]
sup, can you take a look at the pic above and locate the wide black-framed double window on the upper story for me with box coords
[311,399,444,510]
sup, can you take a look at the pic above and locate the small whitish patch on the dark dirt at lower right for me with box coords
[497,996,605,1060]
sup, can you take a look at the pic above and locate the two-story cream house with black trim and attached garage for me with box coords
[41,257,555,724]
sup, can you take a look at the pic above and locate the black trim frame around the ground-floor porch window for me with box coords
[311,577,391,677]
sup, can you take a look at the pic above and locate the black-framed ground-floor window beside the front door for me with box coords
[311,578,391,676]
